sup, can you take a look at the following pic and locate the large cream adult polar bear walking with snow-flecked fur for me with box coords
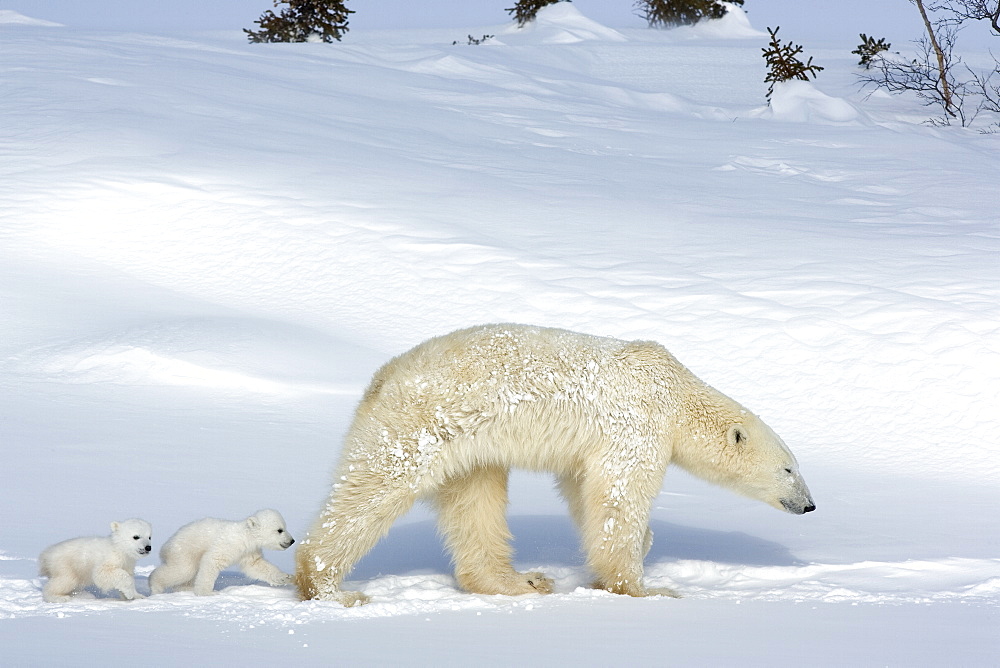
[295,325,815,605]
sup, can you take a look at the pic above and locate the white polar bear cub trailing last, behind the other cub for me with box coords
[38,519,153,603]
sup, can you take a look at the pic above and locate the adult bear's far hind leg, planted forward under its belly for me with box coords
[436,466,552,596]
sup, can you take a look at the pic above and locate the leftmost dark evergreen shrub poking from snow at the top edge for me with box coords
[243,0,354,43]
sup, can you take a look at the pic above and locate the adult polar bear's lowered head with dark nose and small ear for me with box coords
[674,409,816,515]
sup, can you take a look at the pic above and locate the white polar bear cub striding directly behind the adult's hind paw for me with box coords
[149,509,295,596]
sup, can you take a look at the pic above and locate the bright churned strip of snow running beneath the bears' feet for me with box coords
[0,558,1000,627]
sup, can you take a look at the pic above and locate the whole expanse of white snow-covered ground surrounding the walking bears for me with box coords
[0,4,1000,666]
